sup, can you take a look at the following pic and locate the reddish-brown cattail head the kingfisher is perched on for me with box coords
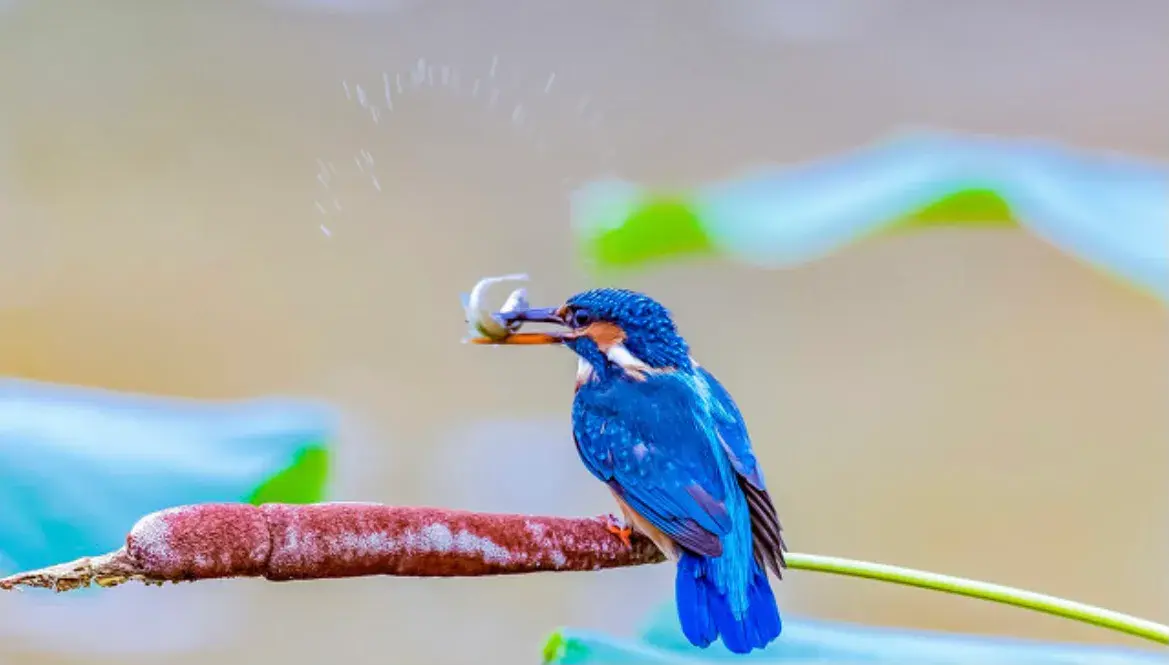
[0,503,664,591]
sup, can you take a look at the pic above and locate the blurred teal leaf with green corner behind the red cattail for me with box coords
[0,380,334,573]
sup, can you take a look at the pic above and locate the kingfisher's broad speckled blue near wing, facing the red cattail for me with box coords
[573,376,731,556]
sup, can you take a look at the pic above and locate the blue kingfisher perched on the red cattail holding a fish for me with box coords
[475,289,787,653]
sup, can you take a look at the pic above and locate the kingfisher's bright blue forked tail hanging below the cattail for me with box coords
[675,553,783,653]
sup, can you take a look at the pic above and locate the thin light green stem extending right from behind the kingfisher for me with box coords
[787,552,1169,644]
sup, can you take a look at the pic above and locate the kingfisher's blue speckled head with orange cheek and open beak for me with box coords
[476,289,691,376]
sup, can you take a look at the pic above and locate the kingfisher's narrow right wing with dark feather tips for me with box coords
[698,367,787,577]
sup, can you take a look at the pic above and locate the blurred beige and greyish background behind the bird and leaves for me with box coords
[0,0,1169,665]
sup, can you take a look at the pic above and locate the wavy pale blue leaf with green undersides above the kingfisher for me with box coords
[572,133,1169,302]
